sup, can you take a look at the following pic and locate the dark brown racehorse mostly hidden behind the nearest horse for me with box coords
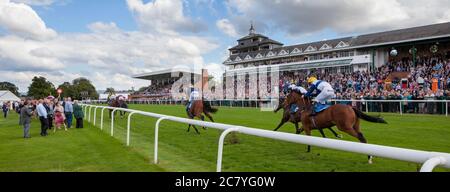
[274,99,342,138]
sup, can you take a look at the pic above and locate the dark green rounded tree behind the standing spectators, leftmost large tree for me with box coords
[28,77,56,99]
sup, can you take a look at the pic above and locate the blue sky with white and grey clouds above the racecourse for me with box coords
[0,0,450,92]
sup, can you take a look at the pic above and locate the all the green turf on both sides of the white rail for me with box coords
[0,105,450,172]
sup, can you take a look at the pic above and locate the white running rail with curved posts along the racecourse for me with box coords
[82,104,450,172]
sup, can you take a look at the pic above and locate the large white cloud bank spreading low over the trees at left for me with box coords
[0,0,217,92]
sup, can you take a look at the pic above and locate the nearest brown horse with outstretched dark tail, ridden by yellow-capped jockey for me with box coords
[285,92,387,163]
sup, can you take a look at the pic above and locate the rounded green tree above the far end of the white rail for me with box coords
[72,77,98,100]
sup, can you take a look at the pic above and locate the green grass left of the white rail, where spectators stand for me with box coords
[0,114,164,172]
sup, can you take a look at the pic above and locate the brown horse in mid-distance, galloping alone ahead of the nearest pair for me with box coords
[187,100,218,134]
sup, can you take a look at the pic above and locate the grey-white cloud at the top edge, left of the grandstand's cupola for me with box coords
[127,0,206,34]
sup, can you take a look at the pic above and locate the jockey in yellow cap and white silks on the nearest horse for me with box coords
[305,77,336,116]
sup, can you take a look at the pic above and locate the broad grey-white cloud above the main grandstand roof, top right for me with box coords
[226,0,450,35]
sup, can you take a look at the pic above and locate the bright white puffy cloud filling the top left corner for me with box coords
[0,0,57,40]
